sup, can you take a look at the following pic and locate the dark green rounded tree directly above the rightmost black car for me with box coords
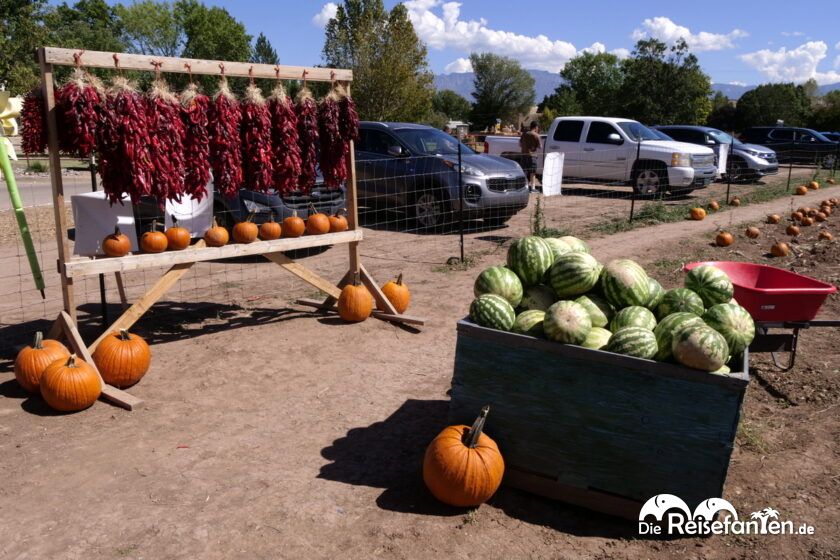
[736,83,811,128]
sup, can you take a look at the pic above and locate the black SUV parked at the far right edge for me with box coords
[741,126,840,169]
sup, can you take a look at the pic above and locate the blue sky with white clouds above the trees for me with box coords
[113,0,840,84]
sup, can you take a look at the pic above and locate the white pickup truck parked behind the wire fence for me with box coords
[484,117,717,194]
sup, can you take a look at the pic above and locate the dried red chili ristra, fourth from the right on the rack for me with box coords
[268,82,300,195]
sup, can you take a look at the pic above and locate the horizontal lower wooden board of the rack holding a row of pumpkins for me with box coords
[65,230,364,278]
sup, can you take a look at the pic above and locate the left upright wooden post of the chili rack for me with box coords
[38,49,76,320]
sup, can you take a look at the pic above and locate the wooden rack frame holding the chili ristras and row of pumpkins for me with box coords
[38,47,424,410]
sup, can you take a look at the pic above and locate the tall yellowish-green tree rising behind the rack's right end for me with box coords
[323,0,433,121]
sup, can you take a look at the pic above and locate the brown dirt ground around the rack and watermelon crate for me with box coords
[0,180,840,559]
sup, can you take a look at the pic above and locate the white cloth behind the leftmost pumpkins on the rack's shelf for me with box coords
[70,191,138,256]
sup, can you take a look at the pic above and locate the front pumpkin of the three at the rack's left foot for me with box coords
[41,354,102,412]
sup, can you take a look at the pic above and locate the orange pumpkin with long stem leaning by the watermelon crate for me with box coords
[423,406,505,507]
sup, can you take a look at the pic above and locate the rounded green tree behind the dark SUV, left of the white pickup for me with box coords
[470,53,535,127]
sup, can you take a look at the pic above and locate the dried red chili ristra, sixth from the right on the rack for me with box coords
[209,77,242,198]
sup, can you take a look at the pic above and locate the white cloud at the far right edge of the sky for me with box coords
[738,41,840,84]
